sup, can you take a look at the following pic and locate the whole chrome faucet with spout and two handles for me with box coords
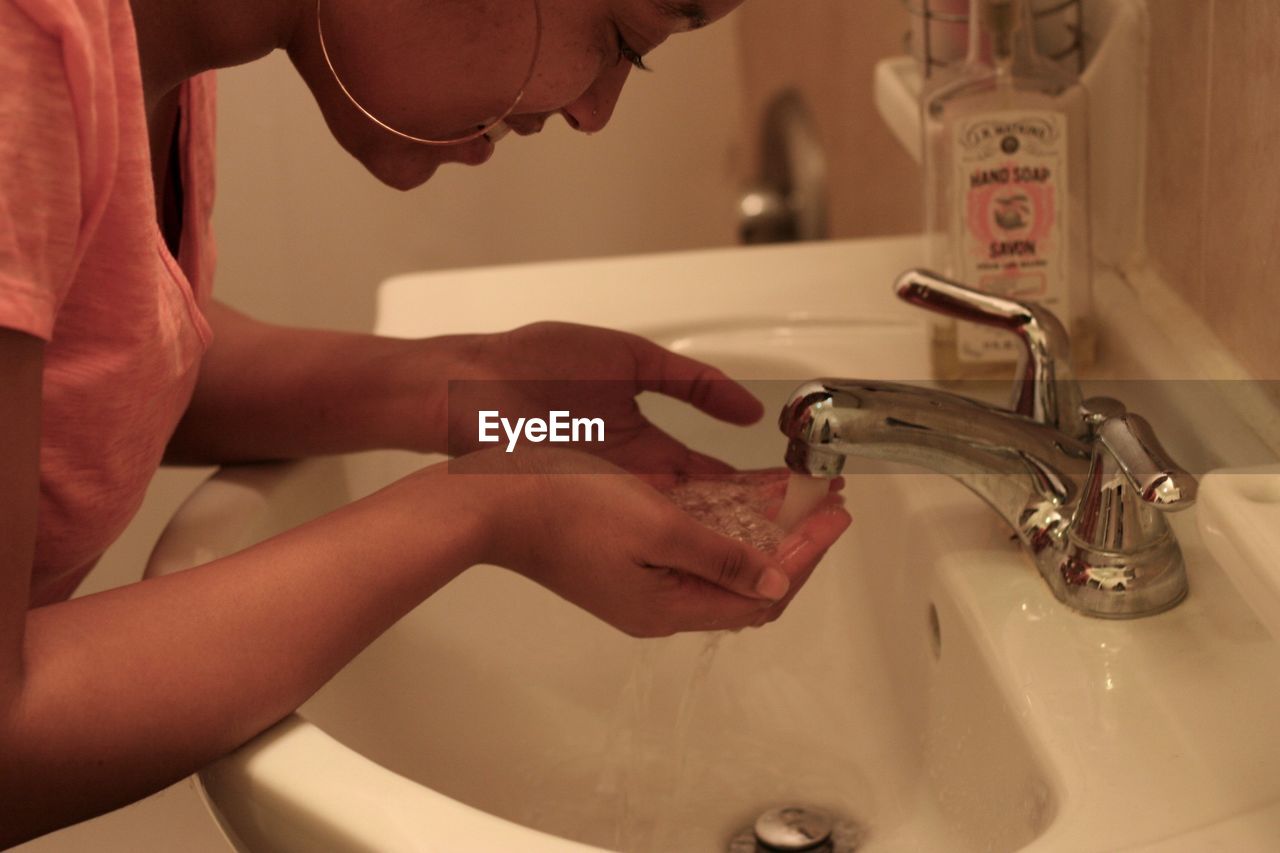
[780,270,1197,619]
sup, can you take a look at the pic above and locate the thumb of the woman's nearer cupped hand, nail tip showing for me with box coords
[660,514,791,601]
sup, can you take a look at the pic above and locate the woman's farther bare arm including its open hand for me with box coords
[165,305,763,473]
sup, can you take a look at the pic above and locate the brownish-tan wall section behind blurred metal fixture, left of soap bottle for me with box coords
[739,0,923,237]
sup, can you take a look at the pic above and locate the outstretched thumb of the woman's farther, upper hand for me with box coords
[634,337,764,425]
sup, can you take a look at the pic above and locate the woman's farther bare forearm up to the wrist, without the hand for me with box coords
[165,295,460,464]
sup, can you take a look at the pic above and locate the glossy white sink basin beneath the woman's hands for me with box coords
[148,240,1280,853]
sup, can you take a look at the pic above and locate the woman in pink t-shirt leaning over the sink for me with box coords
[0,0,849,845]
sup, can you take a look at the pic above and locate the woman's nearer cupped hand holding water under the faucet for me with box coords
[447,448,850,637]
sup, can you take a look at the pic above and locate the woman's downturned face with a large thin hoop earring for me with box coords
[289,0,741,190]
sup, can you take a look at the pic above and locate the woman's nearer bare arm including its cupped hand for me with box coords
[0,320,849,847]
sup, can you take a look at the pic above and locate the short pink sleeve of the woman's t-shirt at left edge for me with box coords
[0,0,83,341]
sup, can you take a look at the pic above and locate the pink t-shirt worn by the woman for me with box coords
[0,0,214,605]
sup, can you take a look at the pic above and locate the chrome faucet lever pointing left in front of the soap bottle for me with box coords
[895,269,1088,438]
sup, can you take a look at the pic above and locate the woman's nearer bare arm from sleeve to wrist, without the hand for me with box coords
[0,329,481,848]
